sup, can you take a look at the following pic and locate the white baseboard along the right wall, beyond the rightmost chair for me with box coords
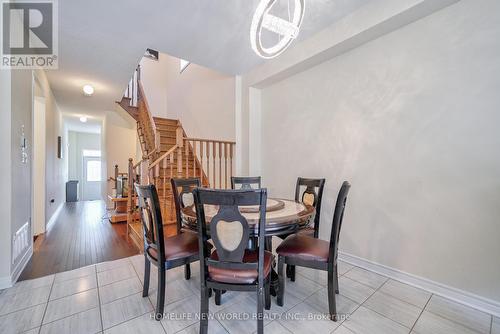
[339,252,500,317]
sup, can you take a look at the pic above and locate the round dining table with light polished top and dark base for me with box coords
[181,198,316,296]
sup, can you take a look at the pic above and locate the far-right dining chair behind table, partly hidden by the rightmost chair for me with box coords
[281,177,326,282]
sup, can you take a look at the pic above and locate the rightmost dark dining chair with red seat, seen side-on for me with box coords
[276,181,351,321]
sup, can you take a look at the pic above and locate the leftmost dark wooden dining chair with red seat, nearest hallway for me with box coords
[135,184,199,320]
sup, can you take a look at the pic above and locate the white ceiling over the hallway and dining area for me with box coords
[48,0,378,115]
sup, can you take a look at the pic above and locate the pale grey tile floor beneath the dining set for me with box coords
[0,255,500,334]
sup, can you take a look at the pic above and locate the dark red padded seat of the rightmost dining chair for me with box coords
[276,233,330,262]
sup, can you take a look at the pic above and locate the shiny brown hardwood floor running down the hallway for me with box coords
[19,201,139,280]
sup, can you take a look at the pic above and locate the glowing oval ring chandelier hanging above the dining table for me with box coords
[250,0,305,59]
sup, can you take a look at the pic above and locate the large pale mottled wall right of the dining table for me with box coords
[258,0,500,301]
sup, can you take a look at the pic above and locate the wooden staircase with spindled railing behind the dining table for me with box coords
[117,66,235,249]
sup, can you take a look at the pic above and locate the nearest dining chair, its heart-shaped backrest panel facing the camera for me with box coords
[193,188,273,334]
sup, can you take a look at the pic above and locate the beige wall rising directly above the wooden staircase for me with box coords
[141,53,235,140]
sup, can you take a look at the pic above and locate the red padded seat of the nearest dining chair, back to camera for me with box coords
[208,250,273,284]
